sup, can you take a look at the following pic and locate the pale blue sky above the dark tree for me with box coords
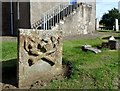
[96,0,120,20]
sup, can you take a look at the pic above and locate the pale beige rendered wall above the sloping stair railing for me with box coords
[30,0,59,25]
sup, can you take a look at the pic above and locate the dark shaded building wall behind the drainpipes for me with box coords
[1,2,30,35]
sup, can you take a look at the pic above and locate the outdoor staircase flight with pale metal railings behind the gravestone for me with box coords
[32,3,81,30]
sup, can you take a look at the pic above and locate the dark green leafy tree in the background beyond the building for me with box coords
[100,8,120,29]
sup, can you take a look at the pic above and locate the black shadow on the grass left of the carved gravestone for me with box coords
[0,59,17,86]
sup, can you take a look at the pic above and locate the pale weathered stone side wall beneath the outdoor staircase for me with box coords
[60,4,95,36]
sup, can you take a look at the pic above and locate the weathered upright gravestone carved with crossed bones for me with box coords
[18,29,62,88]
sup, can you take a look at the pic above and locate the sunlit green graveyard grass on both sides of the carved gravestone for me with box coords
[0,34,119,89]
